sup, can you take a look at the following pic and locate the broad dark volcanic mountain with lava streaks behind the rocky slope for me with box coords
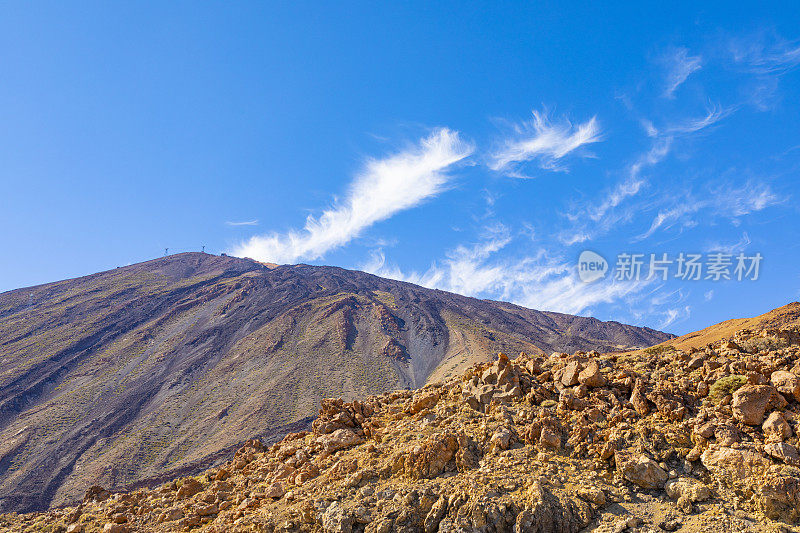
[0,253,671,511]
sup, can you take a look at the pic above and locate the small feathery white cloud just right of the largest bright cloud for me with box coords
[489,111,602,178]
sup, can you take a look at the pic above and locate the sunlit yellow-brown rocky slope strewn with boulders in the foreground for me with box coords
[0,327,800,533]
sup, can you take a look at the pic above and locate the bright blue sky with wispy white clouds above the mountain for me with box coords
[0,2,800,333]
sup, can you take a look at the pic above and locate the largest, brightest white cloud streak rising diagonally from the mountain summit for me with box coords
[232,128,473,264]
